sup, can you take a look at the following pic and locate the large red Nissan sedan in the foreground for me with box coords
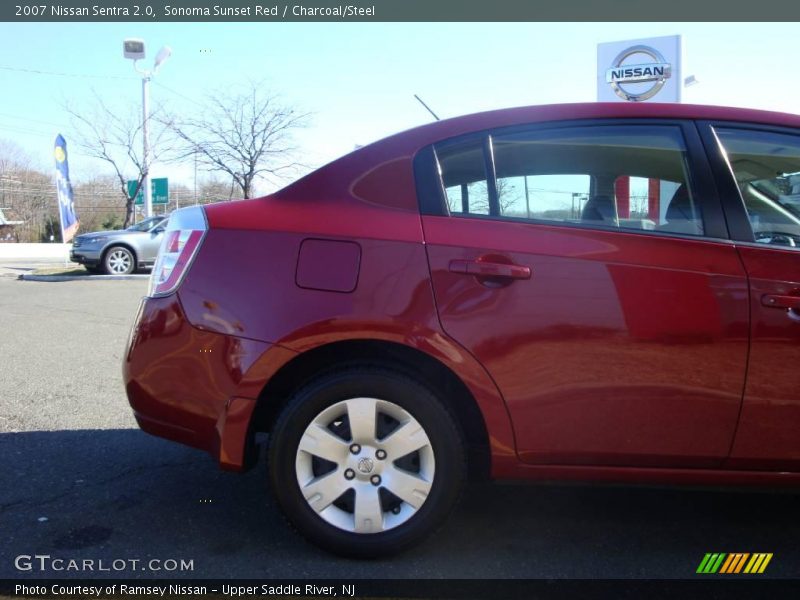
[124,103,800,557]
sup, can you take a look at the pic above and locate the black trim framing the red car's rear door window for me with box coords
[414,118,730,240]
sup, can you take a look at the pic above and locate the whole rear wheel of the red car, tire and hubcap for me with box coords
[269,367,466,558]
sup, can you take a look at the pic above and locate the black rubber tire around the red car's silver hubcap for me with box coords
[269,365,466,558]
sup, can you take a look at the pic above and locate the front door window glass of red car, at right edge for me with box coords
[715,128,800,249]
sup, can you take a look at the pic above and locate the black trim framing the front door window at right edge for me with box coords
[697,121,800,245]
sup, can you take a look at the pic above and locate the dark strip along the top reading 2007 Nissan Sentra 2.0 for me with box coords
[0,0,800,23]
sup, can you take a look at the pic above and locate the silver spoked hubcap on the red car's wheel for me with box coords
[295,398,435,533]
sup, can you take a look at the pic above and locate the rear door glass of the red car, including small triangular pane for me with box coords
[436,125,704,235]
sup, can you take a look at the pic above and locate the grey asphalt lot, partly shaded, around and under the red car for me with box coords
[0,273,800,579]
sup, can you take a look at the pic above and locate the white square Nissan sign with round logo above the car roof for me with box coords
[597,35,681,102]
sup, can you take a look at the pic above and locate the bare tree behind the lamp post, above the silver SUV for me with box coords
[64,94,169,227]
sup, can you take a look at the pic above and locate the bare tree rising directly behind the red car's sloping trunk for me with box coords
[167,82,308,198]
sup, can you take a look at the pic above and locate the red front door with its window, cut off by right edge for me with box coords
[702,123,800,471]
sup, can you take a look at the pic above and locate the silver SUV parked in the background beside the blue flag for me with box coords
[69,215,168,275]
